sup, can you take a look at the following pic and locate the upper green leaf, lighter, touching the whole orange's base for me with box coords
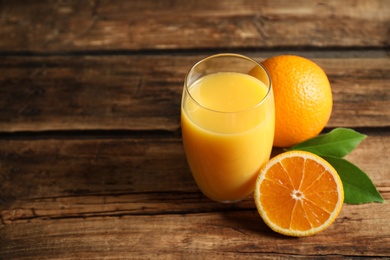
[287,128,367,158]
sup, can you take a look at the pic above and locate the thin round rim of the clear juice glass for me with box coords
[184,53,272,114]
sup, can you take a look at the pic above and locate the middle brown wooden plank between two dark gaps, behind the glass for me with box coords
[0,53,390,132]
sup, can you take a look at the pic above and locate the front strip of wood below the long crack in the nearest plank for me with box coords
[0,204,390,259]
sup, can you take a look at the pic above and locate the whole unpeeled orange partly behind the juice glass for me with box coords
[262,55,333,147]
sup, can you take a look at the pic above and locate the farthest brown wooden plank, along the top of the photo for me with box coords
[0,0,390,52]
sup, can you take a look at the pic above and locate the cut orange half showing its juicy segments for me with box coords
[254,151,344,236]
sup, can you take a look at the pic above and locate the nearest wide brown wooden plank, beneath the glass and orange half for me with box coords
[0,135,390,259]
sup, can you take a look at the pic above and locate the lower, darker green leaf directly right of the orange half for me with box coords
[322,156,385,204]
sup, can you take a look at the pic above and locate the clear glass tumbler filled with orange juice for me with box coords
[181,53,275,203]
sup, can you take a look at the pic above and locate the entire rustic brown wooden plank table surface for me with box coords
[0,0,390,259]
